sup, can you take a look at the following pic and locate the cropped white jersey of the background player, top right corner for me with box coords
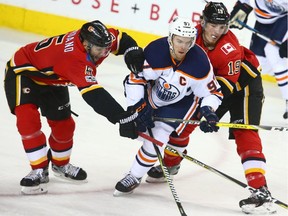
[240,0,288,24]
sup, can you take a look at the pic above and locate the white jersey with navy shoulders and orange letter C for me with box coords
[125,37,223,113]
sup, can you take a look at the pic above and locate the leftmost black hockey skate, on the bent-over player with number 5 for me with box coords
[20,167,49,195]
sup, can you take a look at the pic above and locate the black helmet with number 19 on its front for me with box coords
[202,2,230,25]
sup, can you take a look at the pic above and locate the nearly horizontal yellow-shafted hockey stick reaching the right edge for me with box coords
[154,117,288,131]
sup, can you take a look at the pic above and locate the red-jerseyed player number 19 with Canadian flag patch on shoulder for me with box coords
[146,2,275,213]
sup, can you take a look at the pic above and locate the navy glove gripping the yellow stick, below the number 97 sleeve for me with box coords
[200,106,219,133]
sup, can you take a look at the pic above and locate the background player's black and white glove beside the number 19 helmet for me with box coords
[229,1,253,29]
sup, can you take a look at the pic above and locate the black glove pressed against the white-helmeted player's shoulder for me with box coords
[124,46,145,74]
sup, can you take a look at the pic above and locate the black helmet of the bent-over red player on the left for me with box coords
[80,20,112,47]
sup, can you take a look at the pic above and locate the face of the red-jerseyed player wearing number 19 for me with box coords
[202,22,227,45]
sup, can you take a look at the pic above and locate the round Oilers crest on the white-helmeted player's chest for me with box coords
[155,78,180,101]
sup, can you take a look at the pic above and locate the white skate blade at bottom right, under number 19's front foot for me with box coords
[242,203,277,215]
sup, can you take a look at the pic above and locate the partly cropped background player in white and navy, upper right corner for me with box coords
[230,0,288,119]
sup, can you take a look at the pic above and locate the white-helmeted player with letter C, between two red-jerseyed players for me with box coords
[114,17,223,196]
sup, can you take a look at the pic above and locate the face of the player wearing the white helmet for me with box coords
[171,35,193,61]
